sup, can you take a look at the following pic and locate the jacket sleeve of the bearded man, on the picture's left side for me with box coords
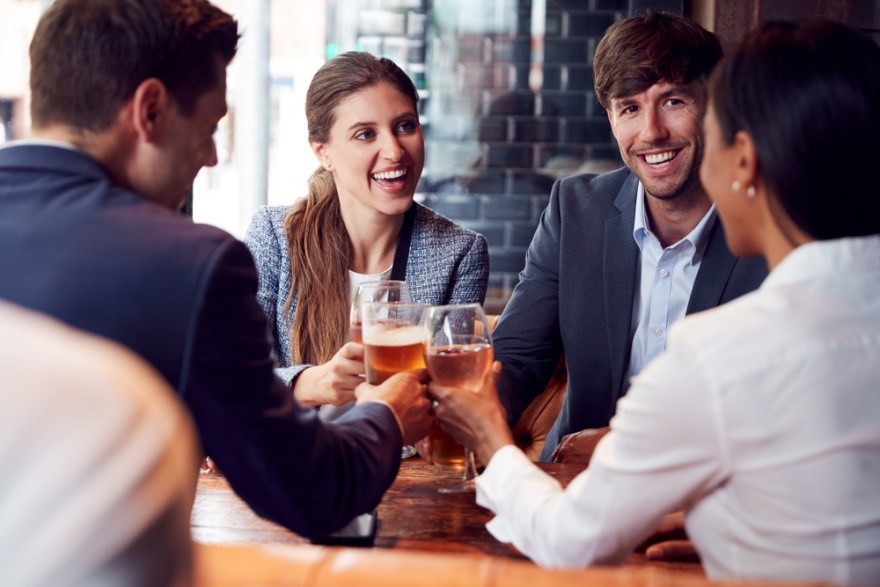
[493,182,562,427]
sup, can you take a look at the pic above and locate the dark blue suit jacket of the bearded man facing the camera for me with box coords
[493,168,767,460]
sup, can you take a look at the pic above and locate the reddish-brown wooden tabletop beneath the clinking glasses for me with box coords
[192,458,702,575]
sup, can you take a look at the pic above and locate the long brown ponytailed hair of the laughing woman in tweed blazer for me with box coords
[284,51,419,365]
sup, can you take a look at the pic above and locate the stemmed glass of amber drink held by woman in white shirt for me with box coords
[425,304,493,493]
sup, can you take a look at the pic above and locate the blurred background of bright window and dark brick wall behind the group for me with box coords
[0,0,880,312]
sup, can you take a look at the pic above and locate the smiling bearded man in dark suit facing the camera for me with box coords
[494,11,767,460]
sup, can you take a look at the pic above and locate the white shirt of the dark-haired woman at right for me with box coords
[477,236,880,584]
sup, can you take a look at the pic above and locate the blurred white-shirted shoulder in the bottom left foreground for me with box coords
[0,302,199,587]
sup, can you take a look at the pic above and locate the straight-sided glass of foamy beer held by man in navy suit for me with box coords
[360,300,428,459]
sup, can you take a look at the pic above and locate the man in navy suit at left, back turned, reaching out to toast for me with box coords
[0,0,431,537]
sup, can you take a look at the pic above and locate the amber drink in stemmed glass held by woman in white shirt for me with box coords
[426,342,493,468]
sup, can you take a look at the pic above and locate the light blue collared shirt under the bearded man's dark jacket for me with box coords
[629,182,715,377]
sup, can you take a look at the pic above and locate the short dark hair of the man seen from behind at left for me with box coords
[30,0,239,131]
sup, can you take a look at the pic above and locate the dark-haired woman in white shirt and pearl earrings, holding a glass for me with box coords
[430,21,880,584]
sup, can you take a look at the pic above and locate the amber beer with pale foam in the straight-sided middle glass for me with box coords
[363,323,425,385]
